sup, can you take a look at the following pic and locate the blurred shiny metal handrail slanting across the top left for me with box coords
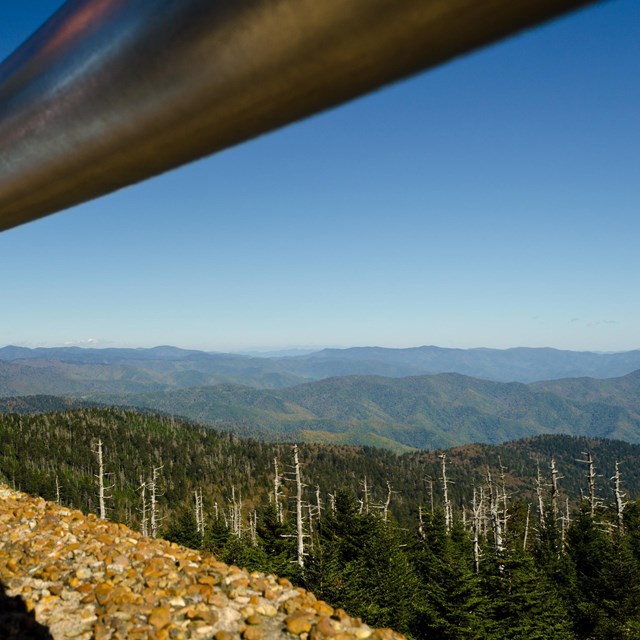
[0,0,589,230]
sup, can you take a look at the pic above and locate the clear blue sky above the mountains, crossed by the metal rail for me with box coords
[0,0,640,351]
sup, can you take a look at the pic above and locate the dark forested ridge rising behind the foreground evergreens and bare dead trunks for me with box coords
[0,408,640,529]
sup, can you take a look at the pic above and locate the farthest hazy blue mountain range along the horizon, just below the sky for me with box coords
[0,346,640,397]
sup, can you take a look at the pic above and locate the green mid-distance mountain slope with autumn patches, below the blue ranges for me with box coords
[63,373,640,452]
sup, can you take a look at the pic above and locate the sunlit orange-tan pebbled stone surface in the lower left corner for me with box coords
[0,485,402,640]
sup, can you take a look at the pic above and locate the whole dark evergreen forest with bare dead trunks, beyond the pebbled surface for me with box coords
[0,409,640,640]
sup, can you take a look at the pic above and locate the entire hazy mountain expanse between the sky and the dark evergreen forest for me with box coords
[5,346,640,452]
